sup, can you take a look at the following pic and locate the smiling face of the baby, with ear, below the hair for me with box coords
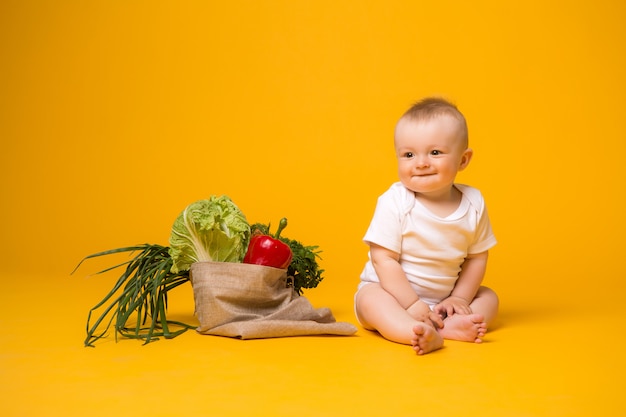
[395,116,472,197]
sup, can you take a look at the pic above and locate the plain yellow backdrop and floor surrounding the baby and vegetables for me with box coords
[0,0,626,416]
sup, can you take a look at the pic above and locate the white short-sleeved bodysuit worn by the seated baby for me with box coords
[359,182,496,307]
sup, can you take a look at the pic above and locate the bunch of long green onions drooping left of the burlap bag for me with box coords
[72,244,195,347]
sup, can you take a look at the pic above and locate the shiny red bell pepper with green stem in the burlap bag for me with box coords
[243,218,293,269]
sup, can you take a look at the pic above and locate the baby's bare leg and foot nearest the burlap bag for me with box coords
[356,283,443,355]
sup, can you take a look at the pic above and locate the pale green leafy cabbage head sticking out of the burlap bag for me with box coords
[169,196,250,273]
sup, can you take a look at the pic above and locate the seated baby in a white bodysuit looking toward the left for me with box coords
[355,98,498,355]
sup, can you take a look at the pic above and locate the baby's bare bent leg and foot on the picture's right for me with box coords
[439,287,498,343]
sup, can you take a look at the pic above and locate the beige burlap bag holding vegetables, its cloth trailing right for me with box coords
[190,262,357,339]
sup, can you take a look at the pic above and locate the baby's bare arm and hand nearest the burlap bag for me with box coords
[370,243,443,327]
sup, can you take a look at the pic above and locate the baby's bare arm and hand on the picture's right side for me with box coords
[435,251,489,316]
